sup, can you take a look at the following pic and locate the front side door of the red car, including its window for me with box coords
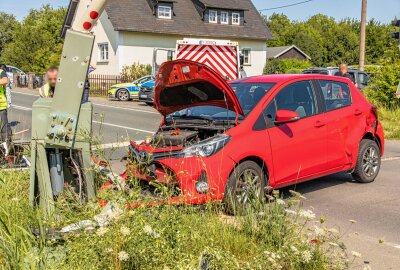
[264,80,327,185]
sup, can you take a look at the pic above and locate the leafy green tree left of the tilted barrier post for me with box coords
[1,5,66,72]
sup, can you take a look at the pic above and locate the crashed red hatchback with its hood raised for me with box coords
[125,60,384,211]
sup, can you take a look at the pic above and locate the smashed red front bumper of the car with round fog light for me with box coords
[104,139,234,207]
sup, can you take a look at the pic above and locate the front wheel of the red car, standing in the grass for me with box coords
[223,161,267,215]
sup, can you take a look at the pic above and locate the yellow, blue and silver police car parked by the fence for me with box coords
[108,76,154,101]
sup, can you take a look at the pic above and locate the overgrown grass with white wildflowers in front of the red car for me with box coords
[0,168,351,270]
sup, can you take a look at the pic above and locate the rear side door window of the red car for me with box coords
[318,80,352,111]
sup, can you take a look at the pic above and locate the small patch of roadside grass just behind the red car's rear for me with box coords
[379,108,400,140]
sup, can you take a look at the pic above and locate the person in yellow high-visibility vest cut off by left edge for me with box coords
[0,65,11,156]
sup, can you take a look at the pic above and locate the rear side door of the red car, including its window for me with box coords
[318,80,361,170]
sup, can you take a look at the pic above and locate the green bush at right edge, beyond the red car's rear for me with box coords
[364,61,400,109]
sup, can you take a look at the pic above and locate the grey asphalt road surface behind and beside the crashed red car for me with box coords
[9,90,400,269]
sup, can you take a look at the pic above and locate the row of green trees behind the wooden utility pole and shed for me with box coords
[265,14,399,67]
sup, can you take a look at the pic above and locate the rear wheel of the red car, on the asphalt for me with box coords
[352,139,381,183]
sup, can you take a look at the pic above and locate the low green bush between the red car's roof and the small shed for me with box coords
[264,59,311,74]
